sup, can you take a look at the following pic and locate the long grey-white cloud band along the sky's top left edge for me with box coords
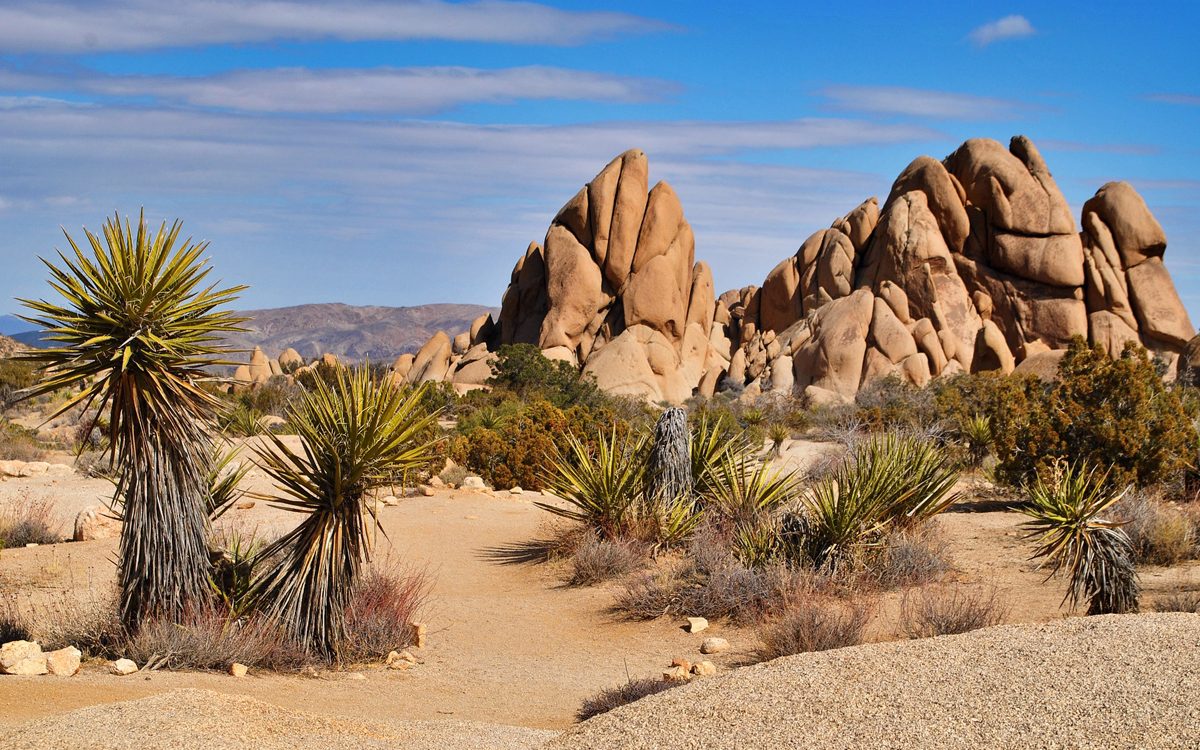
[0,0,668,54]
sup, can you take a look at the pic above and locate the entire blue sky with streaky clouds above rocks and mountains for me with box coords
[0,0,1200,322]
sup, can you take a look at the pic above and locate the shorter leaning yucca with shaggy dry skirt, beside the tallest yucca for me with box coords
[250,367,437,661]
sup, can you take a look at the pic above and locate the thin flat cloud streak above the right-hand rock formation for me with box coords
[818,85,1027,120]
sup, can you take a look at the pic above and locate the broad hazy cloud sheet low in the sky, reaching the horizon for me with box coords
[0,99,944,307]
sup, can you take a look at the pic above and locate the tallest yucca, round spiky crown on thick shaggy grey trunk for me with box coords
[22,215,245,631]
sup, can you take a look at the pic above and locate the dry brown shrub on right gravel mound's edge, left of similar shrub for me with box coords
[758,596,874,661]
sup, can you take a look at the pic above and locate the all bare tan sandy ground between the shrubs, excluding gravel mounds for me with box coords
[0,442,1200,733]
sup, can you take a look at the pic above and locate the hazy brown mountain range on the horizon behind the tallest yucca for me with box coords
[0,302,499,362]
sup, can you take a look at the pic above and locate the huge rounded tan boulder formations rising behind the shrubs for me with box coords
[394,136,1195,403]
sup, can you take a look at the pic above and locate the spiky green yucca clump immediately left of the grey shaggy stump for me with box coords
[538,430,648,540]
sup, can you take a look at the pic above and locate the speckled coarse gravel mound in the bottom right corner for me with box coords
[547,614,1200,750]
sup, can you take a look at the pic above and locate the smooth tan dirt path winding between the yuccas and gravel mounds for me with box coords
[0,484,750,727]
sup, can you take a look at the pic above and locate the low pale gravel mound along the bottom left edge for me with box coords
[0,689,553,750]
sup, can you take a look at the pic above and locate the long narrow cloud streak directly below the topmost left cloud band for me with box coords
[87,66,677,114]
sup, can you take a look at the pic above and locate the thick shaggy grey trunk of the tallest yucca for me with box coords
[116,432,211,630]
